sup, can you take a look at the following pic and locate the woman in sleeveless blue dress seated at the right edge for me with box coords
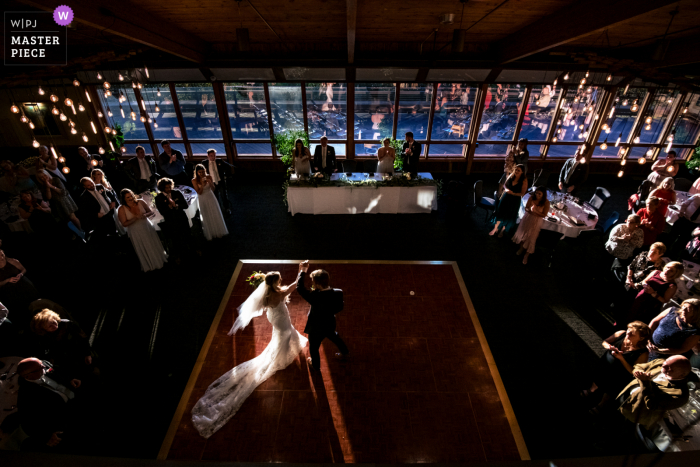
[649,298,700,360]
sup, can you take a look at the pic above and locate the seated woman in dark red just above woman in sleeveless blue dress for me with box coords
[628,261,684,323]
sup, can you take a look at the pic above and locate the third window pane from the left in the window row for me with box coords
[175,83,223,139]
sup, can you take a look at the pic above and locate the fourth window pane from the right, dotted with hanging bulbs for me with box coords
[555,86,603,142]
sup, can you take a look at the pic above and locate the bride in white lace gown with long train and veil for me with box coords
[192,263,307,438]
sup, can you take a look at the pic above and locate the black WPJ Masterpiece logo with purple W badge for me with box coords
[4,5,73,66]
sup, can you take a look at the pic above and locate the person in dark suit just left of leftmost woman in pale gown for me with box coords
[78,177,117,236]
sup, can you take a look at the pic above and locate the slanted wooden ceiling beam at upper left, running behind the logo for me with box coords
[19,0,208,63]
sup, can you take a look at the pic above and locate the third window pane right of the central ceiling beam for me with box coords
[432,83,477,141]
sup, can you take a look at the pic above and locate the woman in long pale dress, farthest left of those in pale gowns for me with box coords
[118,188,168,272]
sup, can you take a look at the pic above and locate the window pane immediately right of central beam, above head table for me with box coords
[355,83,396,142]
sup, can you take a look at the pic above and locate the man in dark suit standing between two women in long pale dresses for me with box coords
[155,178,192,264]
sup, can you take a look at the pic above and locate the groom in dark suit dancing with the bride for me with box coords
[297,260,350,370]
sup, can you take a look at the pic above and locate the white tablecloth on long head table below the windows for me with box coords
[287,173,437,215]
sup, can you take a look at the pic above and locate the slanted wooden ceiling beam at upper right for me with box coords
[495,0,678,64]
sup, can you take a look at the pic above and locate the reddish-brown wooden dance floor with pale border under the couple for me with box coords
[159,261,529,463]
